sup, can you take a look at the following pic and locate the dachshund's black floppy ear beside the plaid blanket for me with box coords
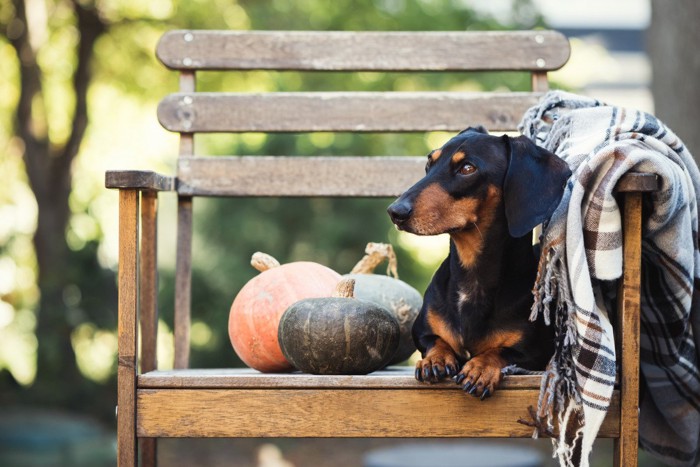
[503,135,571,237]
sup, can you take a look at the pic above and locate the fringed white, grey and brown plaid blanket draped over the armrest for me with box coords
[520,91,700,466]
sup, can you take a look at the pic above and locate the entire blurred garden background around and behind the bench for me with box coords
[0,0,700,465]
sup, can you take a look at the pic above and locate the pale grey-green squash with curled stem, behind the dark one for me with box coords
[343,243,423,365]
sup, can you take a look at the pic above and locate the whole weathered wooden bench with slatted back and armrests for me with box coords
[106,31,656,466]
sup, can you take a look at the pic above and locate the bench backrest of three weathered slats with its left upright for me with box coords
[157,31,570,368]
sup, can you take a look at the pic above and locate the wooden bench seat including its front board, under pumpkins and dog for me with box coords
[136,367,620,438]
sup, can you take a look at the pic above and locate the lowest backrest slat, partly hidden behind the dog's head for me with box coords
[177,156,426,197]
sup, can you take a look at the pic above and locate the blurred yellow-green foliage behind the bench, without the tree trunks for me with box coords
[0,0,541,414]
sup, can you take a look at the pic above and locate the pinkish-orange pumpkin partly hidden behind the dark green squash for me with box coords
[228,253,340,373]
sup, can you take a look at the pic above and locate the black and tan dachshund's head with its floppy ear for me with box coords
[387,127,571,237]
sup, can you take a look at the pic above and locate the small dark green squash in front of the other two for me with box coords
[278,279,399,375]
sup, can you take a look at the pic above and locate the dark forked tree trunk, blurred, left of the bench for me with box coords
[8,0,106,408]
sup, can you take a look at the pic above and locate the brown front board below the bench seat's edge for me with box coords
[136,387,620,438]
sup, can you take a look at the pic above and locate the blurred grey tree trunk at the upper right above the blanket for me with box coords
[647,0,700,161]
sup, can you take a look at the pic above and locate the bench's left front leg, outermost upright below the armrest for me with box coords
[117,190,139,467]
